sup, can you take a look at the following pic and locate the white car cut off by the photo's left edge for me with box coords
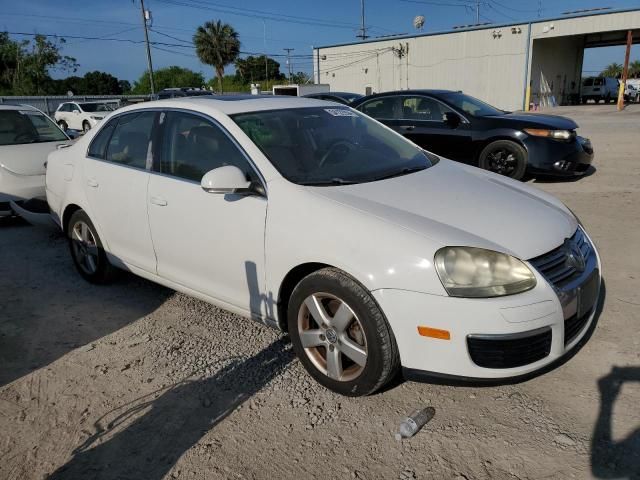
[0,105,69,217]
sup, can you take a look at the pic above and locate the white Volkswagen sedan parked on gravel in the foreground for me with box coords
[47,96,601,396]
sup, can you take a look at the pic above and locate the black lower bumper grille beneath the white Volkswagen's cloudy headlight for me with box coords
[467,328,551,368]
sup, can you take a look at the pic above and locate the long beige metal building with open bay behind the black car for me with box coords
[313,9,640,110]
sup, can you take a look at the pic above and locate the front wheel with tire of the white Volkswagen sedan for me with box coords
[288,268,400,397]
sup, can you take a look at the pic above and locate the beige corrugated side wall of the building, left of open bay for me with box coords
[316,25,527,109]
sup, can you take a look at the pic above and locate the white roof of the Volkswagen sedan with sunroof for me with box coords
[111,95,340,115]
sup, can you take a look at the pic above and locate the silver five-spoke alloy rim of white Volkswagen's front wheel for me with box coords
[298,293,367,382]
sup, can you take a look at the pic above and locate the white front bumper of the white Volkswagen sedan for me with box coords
[373,227,601,380]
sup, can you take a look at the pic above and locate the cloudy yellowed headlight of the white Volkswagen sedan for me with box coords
[435,247,536,298]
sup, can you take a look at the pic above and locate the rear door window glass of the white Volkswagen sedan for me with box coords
[106,112,156,168]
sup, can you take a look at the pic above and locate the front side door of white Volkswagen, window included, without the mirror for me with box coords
[148,111,267,316]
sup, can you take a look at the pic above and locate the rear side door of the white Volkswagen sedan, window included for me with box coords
[84,111,157,273]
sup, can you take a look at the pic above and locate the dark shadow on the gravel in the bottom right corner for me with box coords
[591,366,640,480]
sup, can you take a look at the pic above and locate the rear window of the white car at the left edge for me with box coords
[0,110,68,145]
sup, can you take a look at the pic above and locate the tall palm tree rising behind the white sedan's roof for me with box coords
[193,20,240,93]
